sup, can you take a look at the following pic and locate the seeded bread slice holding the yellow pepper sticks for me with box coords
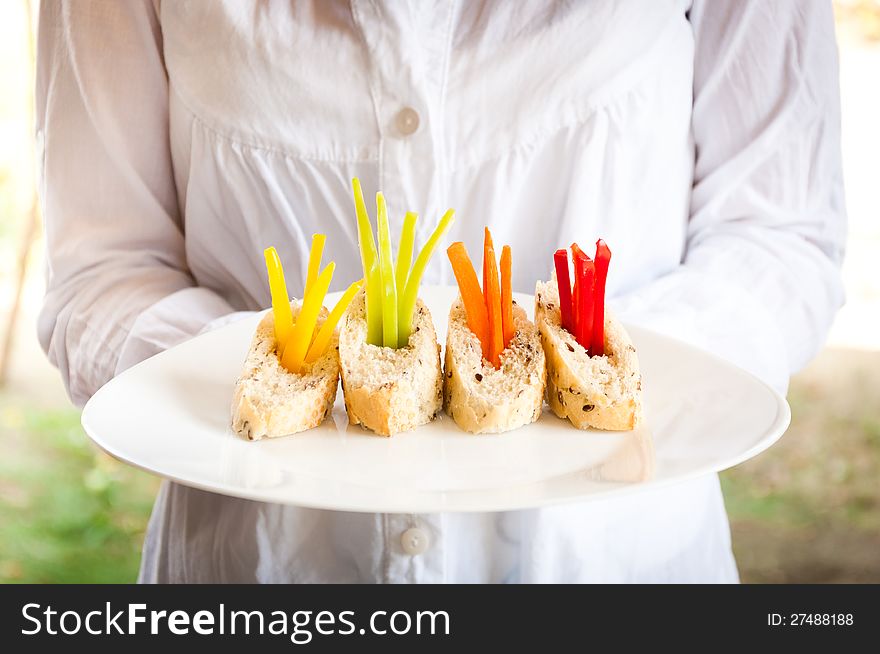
[232,300,339,441]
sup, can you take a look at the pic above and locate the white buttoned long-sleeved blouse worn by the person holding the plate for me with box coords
[37,0,845,582]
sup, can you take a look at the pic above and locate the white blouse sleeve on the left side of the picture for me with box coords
[36,0,232,404]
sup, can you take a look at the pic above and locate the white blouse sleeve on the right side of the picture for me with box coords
[616,0,846,390]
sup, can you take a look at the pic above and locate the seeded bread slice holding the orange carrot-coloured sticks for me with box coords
[443,297,546,434]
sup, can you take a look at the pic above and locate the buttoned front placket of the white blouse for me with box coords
[352,0,457,582]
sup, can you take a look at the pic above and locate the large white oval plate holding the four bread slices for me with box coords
[82,287,791,513]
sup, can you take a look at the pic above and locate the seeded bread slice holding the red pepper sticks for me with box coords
[535,276,642,431]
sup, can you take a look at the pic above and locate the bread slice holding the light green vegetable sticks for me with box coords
[339,289,443,436]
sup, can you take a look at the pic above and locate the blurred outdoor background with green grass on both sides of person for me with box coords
[0,0,880,583]
